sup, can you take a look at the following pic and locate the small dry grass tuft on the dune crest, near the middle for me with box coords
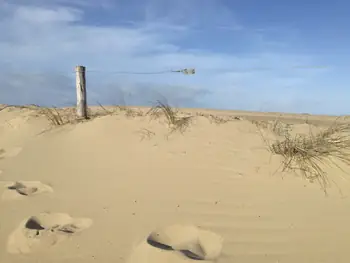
[147,100,193,133]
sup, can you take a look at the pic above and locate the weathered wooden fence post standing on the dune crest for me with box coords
[75,66,88,119]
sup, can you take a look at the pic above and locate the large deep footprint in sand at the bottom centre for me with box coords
[127,225,223,263]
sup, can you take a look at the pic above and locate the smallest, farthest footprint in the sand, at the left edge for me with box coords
[2,181,53,200]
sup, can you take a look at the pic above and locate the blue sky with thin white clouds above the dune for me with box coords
[0,0,350,114]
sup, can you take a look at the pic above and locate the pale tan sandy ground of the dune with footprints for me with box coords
[0,105,350,263]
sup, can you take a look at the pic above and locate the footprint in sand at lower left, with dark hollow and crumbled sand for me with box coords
[7,213,92,254]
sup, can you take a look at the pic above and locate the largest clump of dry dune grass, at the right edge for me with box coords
[269,124,350,193]
